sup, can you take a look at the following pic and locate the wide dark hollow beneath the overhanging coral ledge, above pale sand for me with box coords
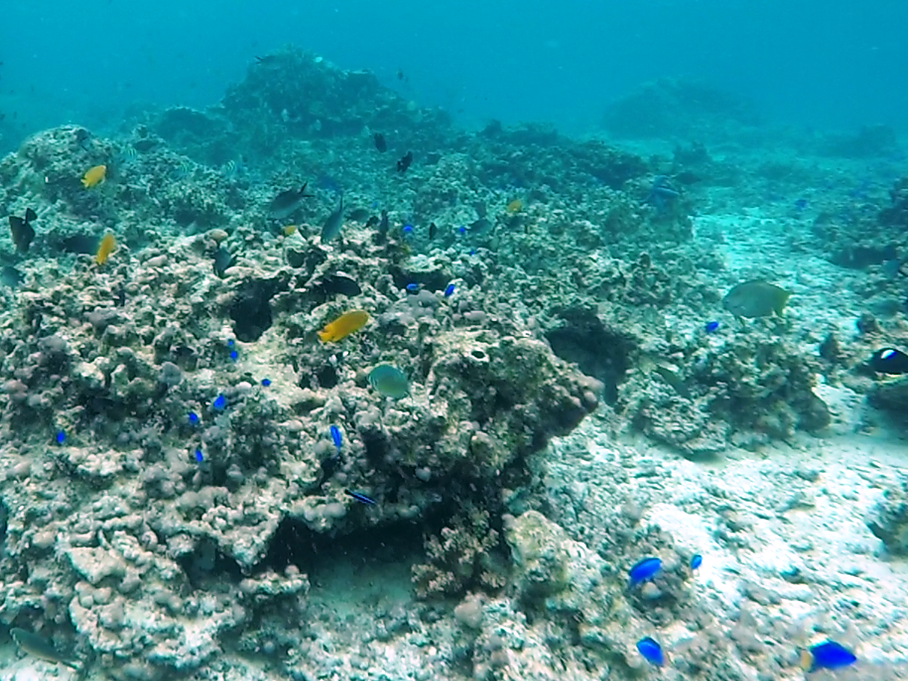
[254,506,423,578]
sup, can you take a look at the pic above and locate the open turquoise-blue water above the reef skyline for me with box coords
[0,0,908,148]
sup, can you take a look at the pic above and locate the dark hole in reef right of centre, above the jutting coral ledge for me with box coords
[546,308,634,404]
